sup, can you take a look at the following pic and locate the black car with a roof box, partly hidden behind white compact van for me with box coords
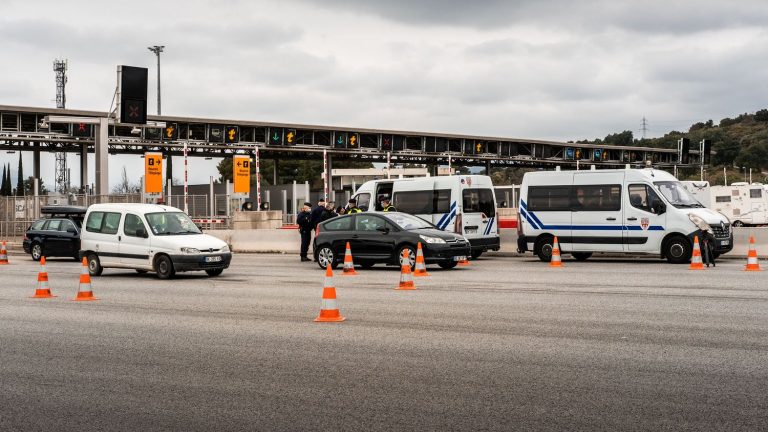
[23,206,87,261]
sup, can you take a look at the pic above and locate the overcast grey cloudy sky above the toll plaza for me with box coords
[0,0,768,189]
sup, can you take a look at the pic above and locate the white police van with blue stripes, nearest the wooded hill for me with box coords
[517,168,733,263]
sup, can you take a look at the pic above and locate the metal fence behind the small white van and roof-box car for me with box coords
[0,194,236,241]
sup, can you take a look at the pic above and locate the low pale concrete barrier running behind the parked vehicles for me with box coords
[205,227,768,258]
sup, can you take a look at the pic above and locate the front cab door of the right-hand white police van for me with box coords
[623,183,667,252]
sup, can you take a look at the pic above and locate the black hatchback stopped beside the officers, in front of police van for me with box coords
[314,212,470,269]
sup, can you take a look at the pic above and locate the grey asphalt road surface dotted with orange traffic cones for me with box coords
[0,251,768,431]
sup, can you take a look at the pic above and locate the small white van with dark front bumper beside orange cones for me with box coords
[80,204,232,279]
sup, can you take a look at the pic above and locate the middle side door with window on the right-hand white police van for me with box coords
[571,171,624,252]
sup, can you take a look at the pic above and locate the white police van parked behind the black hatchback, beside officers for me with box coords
[353,175,501,258]
